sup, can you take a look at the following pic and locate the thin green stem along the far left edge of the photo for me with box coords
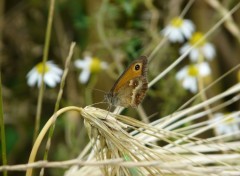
[0,72,7,176]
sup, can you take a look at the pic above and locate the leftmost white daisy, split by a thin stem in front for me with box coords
[27,61,63,88]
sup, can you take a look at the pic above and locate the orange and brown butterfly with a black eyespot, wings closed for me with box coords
[105,56,148,108]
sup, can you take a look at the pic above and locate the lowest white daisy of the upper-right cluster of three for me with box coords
[176,62,211,93]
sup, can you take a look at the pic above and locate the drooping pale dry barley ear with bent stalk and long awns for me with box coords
[23,84,240,176]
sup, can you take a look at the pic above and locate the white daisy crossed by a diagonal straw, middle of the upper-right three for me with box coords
[180,32,216,62]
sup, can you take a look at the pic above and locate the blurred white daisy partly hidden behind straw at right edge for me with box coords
[211,113,240,135]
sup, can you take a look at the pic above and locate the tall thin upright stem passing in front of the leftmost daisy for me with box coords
[33,0,55,141]
